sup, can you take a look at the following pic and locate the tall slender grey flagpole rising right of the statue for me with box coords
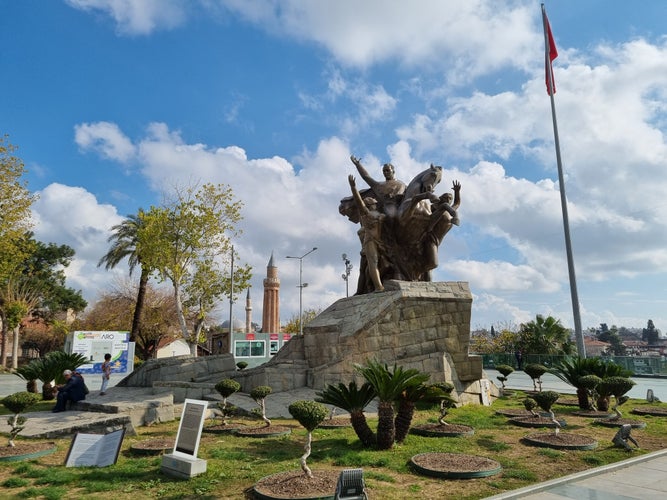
[542,4,586,358]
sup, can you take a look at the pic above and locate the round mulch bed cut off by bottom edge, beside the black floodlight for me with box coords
[253,469,340,500]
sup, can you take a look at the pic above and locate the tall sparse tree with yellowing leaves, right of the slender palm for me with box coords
[139,184,251,356]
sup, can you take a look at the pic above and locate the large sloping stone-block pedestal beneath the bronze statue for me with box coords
[235,281,498,404]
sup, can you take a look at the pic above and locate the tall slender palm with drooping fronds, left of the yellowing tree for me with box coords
[97,209,150,342]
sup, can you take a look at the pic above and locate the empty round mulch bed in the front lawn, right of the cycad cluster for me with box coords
[410,453,502,479]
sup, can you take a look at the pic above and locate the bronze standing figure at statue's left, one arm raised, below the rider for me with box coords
[348,175,385,292]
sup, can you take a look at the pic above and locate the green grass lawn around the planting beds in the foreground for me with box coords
[0,391,667,500]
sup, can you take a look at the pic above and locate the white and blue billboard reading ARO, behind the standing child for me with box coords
[66,331,134,373]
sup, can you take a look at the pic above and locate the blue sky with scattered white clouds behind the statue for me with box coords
[0,0,667,331]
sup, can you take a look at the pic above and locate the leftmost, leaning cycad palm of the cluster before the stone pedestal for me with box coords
[315,381,376,448]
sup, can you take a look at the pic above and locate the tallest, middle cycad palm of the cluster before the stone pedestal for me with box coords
[356,360,423,450]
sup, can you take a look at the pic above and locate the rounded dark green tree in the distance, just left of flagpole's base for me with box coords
[518,314,576,355]
